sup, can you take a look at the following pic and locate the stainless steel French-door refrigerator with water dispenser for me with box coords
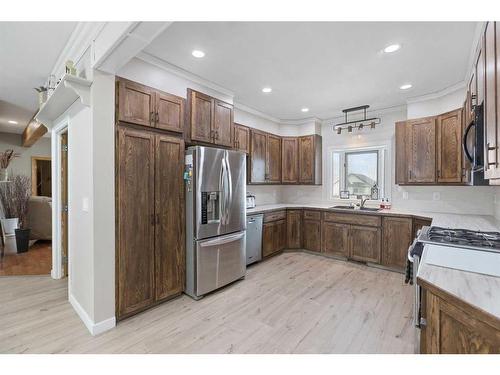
[185,146,246,299]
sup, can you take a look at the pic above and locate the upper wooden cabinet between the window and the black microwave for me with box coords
[395,108,470,185]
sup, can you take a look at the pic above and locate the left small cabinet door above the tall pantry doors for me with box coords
[117,78,155,126]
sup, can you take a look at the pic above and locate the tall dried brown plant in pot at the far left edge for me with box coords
[0,175,31,253]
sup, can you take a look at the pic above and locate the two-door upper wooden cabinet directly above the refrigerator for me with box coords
[187,89,234,147]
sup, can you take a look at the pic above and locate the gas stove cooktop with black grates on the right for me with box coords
[418,227,500,253]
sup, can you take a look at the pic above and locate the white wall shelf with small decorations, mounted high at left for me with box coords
[35,74,92,129]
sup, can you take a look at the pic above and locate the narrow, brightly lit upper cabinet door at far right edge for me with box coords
[484,22,500,178]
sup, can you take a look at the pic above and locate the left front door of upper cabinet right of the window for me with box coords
[407,117,436,183]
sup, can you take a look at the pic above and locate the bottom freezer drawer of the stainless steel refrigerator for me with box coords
[195,231,246,297]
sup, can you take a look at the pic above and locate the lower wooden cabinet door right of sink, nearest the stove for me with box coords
[382,217,413,270]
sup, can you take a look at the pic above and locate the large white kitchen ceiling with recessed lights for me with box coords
[144,22,476,119]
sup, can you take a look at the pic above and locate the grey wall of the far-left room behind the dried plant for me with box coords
[0,133,50,185]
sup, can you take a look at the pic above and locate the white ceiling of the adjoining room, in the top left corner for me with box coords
[0,22,76,133]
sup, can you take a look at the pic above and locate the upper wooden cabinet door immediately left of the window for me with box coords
[298,134,322,185]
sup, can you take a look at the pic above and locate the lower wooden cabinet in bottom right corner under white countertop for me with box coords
[420,288,500,354]
